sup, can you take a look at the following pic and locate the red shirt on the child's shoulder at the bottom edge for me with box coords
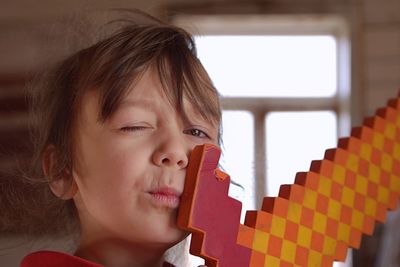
[20,251,174,267]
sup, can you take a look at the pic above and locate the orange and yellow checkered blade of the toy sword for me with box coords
[237,98,400,267]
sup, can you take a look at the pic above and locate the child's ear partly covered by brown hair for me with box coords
[42,145,78,200]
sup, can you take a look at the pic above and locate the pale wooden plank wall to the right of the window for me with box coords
[361,0,400,114]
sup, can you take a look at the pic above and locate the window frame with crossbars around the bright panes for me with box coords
[173,15,351,207]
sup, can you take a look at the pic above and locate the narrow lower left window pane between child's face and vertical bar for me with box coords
[220,111,255,216]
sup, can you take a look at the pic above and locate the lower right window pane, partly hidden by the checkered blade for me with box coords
[266,111,337,196]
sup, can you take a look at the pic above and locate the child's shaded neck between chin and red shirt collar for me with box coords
[75,240,165,267]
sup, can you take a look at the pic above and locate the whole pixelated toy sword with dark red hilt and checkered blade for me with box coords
[178,93,400,267]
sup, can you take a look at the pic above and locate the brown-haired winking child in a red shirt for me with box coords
[15,8,221,267]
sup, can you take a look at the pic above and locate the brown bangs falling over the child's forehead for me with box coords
[85,25,221,125]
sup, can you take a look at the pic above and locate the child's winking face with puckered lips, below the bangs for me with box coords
[69,68,218,251]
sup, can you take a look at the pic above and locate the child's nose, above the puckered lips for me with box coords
[153,138,189,169]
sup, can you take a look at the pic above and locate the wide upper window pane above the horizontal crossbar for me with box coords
[195,35,336,97]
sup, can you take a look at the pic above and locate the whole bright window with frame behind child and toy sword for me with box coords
[176,16,351,266]
